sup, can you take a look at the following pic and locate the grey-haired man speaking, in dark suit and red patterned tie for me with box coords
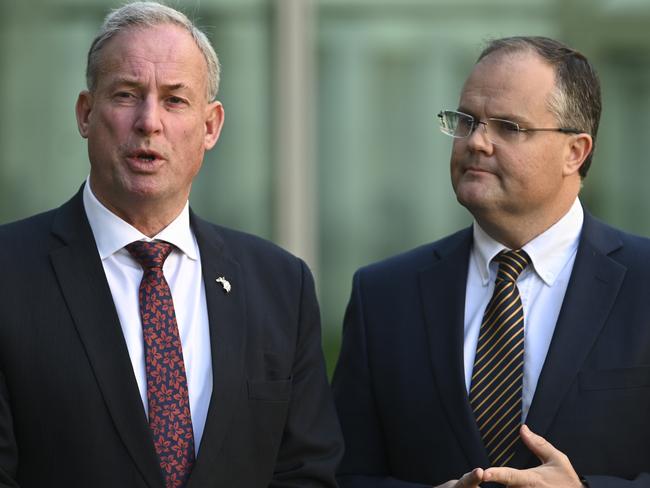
[0,2,342,488]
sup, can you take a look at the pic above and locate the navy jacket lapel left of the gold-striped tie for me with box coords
[420,228,488,467]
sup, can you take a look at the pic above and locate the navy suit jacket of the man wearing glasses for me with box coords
[333,215,650,488]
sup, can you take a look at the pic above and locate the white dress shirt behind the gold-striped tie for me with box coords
[464,198,584,421]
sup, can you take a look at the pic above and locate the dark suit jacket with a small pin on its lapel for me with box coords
[0,189,342,488]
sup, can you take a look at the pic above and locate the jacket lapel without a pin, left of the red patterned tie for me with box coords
[50,191,164,487]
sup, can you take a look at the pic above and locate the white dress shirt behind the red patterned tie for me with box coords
[83,179,212,453]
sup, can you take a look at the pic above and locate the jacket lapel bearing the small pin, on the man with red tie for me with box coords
[188,214,246,488]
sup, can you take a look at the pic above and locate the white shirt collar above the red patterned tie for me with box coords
[83,177,198,260]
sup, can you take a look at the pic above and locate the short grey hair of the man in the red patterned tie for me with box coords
[86,2,220,101]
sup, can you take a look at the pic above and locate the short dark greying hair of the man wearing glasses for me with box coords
[477,36,602,178]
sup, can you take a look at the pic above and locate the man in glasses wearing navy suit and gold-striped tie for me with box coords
[333,37,650,488]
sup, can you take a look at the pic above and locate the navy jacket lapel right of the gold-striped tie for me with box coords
[515,212,626,466]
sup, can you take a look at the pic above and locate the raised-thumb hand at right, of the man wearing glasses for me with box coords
[483,425,583,488]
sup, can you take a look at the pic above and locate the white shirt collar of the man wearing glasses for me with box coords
[472,198,584,286]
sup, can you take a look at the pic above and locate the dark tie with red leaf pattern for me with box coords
[126,241,194,488]
